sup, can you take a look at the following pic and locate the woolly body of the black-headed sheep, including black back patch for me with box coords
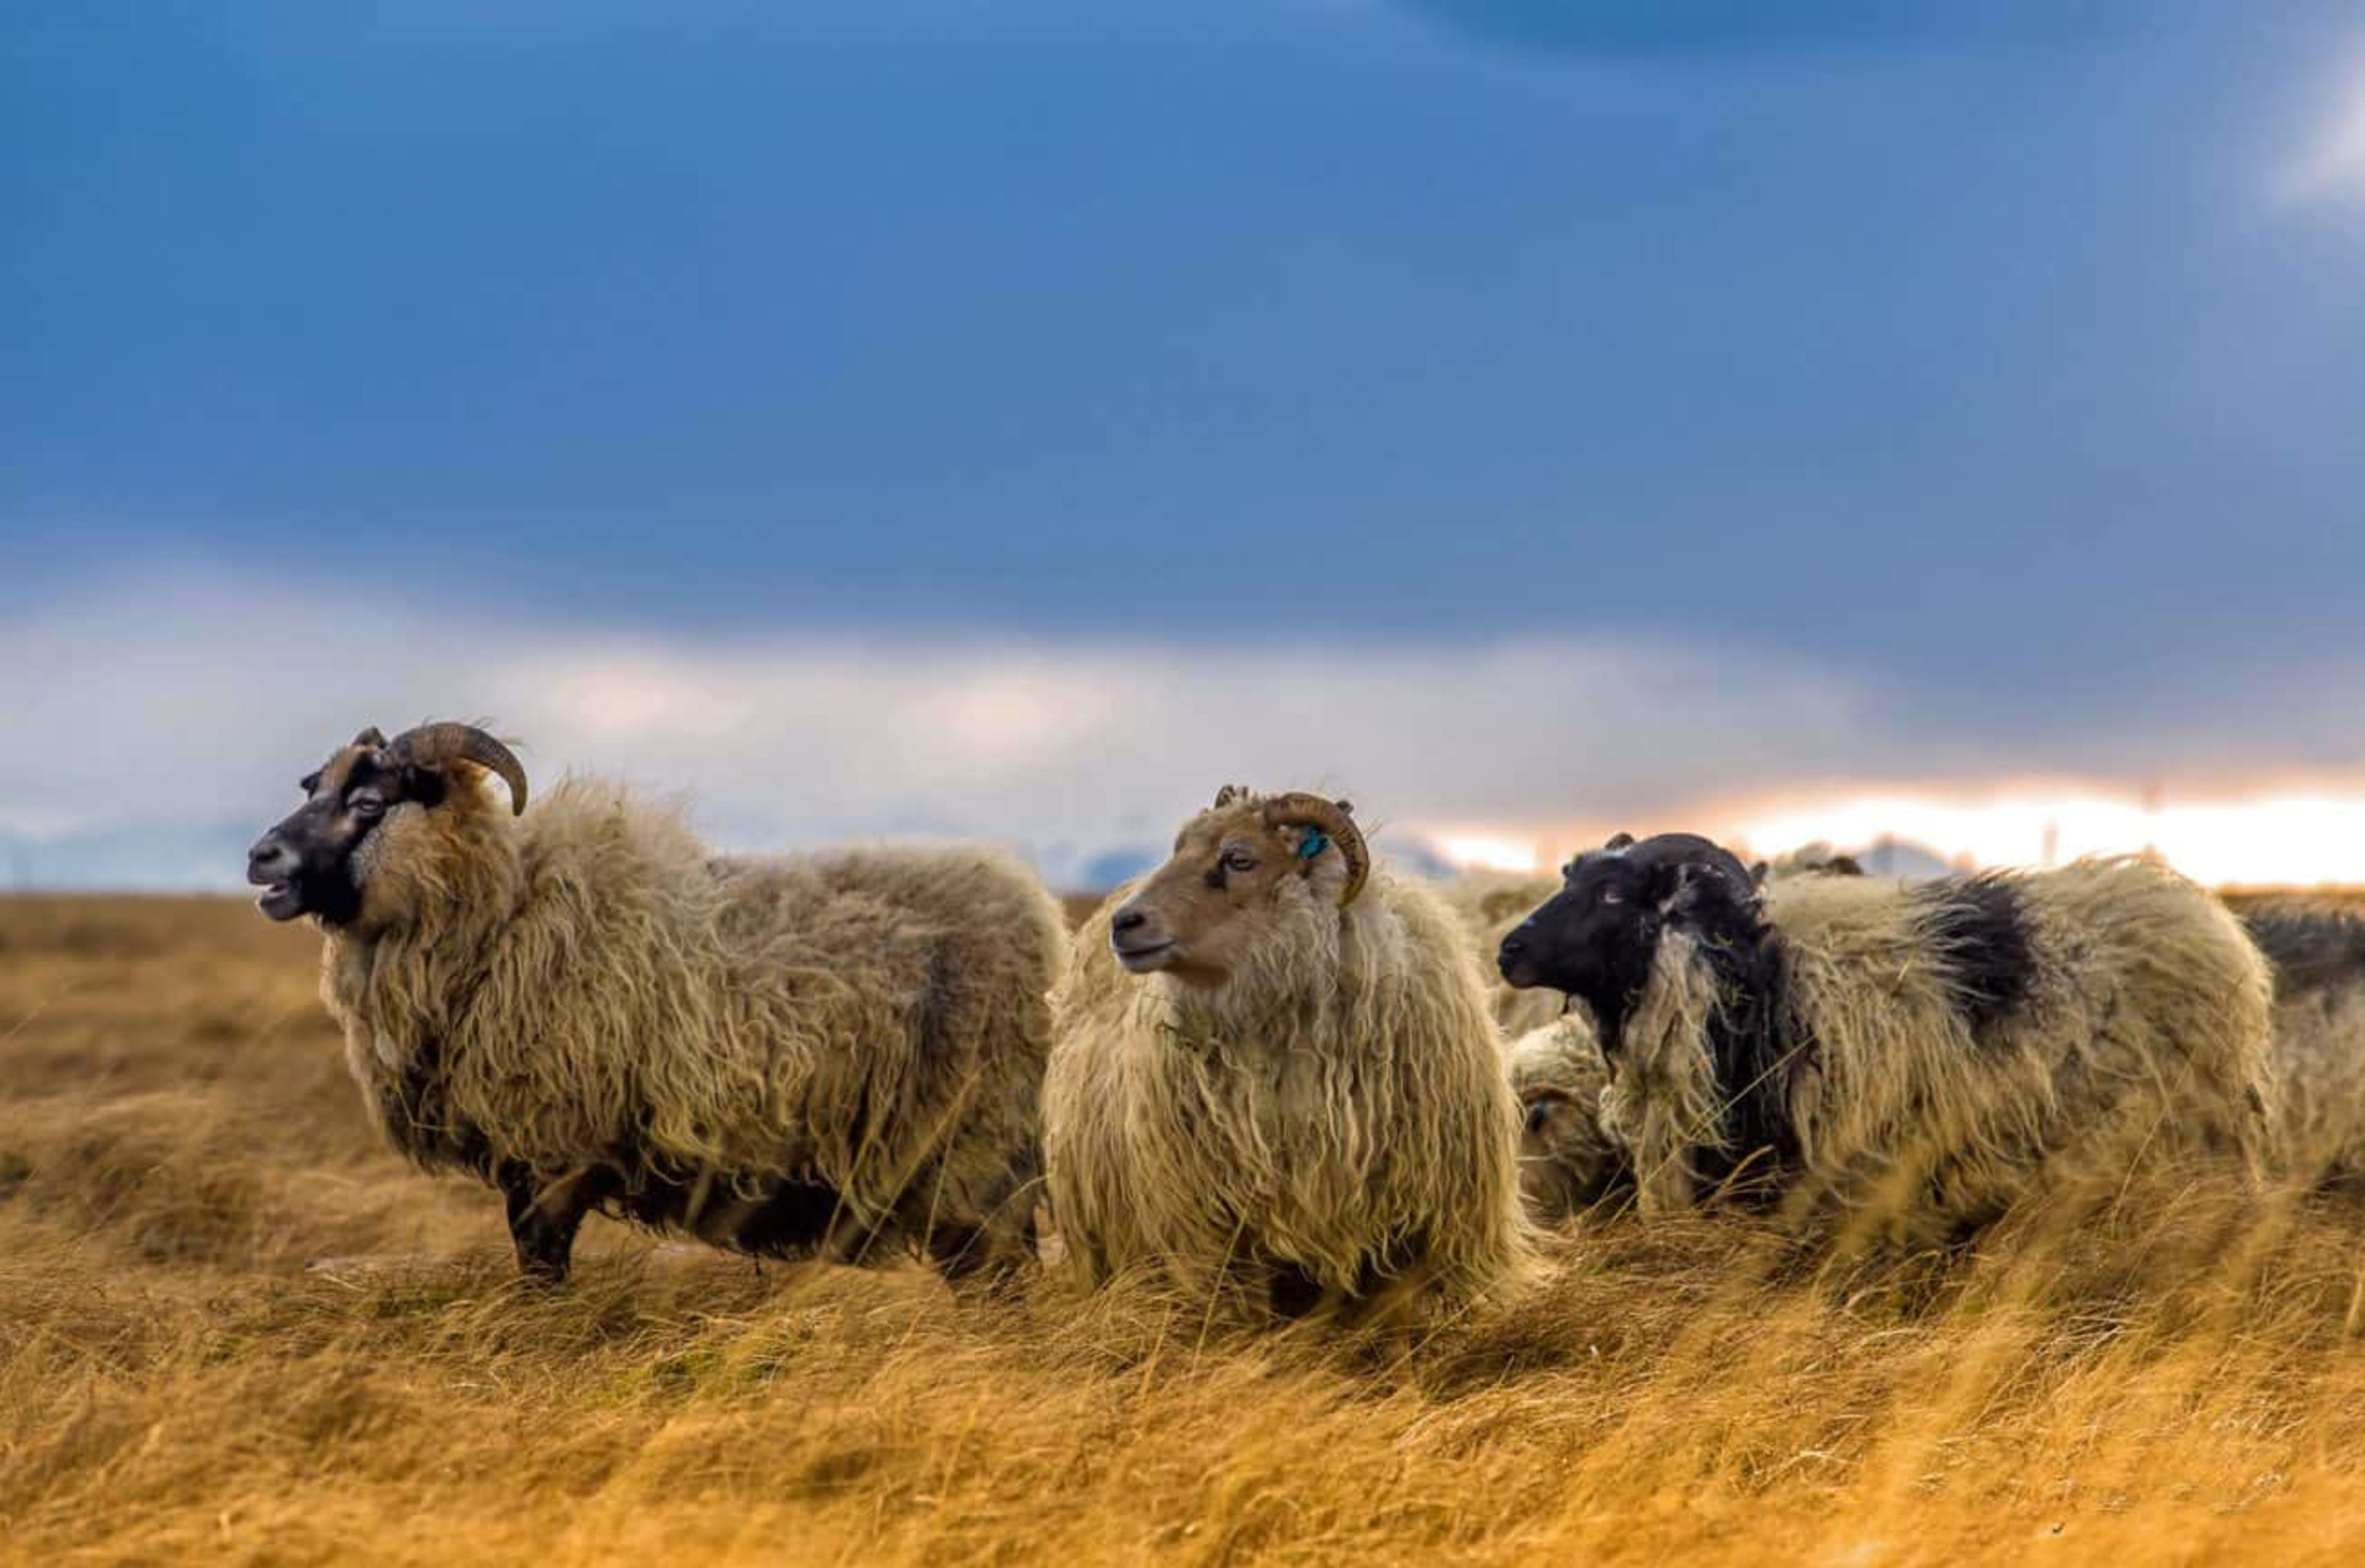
[1766,861,2268,1232]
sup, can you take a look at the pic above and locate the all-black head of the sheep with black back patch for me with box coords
[1495,833,1757,1041]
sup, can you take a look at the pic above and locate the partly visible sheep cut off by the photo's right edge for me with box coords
[2242,906,2365,1187]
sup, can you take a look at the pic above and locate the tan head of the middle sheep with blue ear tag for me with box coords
[1109,785,1372,986]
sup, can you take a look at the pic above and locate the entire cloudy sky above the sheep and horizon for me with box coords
[0,0,2365,887]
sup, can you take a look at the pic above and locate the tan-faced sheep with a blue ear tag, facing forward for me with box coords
[1043,785,1530,1324]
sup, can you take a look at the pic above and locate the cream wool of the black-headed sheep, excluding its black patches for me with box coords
[1601,859,2270,1242]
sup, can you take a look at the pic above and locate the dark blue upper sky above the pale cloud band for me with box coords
[0,0,2365,738]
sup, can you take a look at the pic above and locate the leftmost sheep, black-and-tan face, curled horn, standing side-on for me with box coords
[248,724,1067,1282]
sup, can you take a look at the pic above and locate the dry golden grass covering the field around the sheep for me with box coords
[0,901,2365,1563]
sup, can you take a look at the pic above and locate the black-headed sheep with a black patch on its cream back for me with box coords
[1500,835,2270,1244]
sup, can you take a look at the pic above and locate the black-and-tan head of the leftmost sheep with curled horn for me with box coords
[246,724,525,924]
